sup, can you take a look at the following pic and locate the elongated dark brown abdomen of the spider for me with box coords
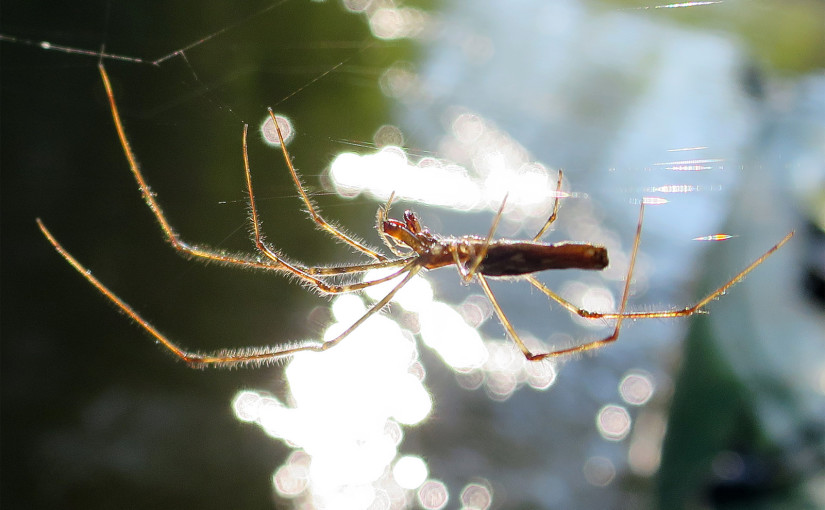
[478,241,608,277]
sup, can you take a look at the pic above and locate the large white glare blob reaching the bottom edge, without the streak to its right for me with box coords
[229,288,432,508]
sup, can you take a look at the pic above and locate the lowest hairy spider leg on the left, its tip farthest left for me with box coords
[37,218,422,368]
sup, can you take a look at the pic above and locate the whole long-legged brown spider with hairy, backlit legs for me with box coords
[37,64,794,367]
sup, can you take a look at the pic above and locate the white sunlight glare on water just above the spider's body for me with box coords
[330,112,571,218]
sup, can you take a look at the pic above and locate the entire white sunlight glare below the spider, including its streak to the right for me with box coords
[233,260,555,509]
